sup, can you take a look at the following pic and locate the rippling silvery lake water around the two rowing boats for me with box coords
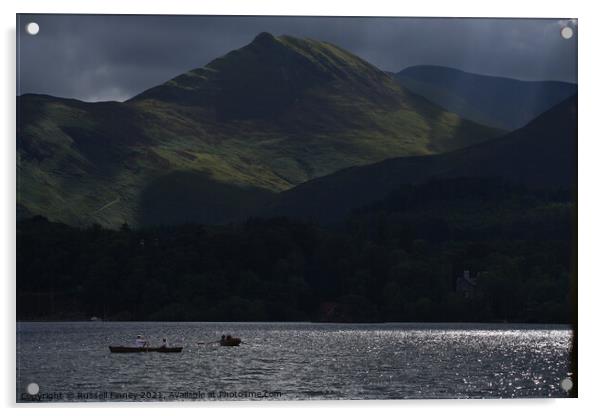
[17,322,571,401]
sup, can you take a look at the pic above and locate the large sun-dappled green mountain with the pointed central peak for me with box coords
[17,33,500,227]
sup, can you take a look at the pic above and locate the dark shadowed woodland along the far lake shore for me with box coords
[17,178,574,323]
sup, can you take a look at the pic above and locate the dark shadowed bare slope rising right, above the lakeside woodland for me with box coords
[264,96,577,222]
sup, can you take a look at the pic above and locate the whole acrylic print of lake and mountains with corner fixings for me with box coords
[16,15,578,402]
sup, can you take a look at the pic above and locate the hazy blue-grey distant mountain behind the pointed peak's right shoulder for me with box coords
[395,65,577,130]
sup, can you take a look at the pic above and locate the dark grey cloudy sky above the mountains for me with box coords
[17,14,578,101]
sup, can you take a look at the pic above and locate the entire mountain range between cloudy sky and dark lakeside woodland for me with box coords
[17,33,576,227]
